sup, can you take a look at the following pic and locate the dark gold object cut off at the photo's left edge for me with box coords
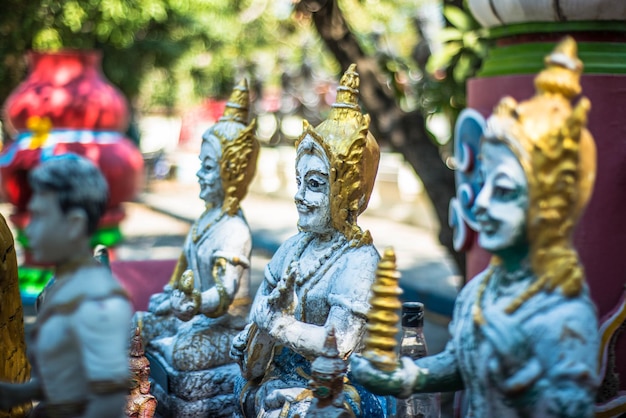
[0,215,30,418]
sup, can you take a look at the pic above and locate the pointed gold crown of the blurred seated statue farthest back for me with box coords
[204,79,259,216]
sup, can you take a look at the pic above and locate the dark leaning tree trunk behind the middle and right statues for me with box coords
[302,0,465,274]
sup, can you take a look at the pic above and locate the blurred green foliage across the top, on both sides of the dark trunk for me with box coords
[0,0,486,124]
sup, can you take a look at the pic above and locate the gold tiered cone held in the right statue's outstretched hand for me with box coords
[363,248,402,371]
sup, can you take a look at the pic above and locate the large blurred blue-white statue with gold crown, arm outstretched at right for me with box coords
[351,38,599,417]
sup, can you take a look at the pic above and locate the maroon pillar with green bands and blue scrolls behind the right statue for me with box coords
[451,0,626,416]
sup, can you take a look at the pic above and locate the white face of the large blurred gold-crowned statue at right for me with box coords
[474,142,528,255]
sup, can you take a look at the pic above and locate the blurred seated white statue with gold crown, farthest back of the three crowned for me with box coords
[134,80,259,416]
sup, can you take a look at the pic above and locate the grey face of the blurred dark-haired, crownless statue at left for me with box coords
[25,192,76,264]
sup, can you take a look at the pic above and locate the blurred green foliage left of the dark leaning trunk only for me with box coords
[0,0,336,110]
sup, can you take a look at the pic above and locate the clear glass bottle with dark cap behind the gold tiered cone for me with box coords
[396,302,441,418]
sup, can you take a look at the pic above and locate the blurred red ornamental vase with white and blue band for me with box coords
[0,51,143,232]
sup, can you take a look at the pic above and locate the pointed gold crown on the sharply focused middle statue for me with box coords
[296,64,380,246]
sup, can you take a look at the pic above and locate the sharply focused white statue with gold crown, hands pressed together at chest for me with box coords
[231,65,380,417]
